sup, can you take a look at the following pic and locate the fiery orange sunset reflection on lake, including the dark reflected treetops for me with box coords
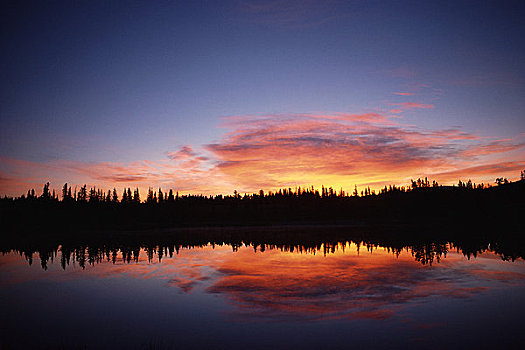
[3,241,525,320]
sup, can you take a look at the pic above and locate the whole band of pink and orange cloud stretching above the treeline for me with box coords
[0,113,525,195]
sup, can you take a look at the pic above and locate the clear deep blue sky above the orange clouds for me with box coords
[0,0,525,193]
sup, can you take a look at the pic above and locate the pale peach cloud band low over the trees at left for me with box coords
[0,154,232,196]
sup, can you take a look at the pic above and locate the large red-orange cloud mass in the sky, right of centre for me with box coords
[204,114,516,191]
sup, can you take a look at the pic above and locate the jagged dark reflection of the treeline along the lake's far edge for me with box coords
[5,230,525,269]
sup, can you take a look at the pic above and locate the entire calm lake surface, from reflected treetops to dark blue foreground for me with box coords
[0,234,525,349]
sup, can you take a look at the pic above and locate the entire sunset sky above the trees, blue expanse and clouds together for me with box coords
[0,0,525,196]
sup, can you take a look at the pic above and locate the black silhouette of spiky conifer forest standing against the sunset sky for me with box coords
[0,171,525,235]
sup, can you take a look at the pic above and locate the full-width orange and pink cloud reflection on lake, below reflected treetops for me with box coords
[4,243,525,320]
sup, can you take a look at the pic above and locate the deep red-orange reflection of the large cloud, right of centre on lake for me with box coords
[208,246,523,319]
